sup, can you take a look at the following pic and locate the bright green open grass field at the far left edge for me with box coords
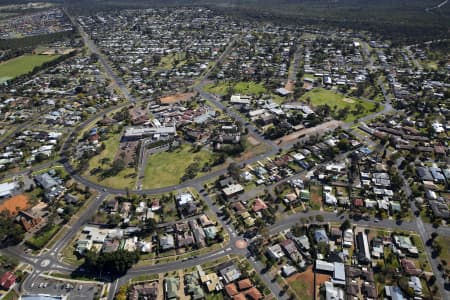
[0,55,59,83]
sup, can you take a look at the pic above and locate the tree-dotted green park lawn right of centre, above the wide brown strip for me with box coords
[300,88,383,122]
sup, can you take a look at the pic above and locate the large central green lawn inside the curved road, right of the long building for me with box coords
[143,145,212,189]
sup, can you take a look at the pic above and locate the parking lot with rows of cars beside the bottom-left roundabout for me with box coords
[27,277,102,300]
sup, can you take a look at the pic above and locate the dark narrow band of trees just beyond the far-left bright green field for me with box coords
[0,30,77,50]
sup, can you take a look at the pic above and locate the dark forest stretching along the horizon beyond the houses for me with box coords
[0,0,450,43]
